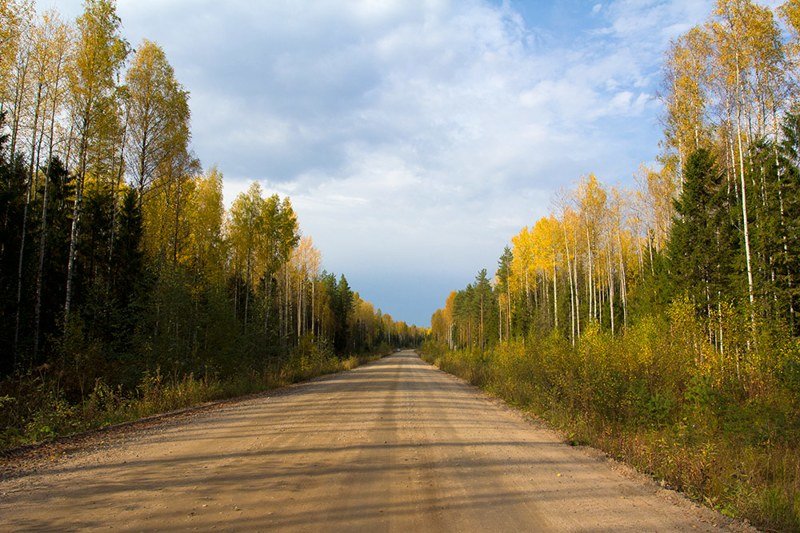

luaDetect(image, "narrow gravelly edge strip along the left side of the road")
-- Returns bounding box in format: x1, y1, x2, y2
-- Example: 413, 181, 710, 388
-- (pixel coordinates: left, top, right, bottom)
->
0, 352, 394, 482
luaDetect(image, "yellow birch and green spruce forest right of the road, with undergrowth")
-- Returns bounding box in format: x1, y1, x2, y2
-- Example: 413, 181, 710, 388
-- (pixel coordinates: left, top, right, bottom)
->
424, 0, 800, 531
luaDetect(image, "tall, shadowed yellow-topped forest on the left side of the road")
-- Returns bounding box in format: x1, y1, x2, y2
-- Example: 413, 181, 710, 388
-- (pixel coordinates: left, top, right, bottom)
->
0, 0, 424, 449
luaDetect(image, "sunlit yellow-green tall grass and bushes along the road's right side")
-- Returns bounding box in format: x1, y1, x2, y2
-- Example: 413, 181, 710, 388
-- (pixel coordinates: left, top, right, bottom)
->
423, 304, 800, 531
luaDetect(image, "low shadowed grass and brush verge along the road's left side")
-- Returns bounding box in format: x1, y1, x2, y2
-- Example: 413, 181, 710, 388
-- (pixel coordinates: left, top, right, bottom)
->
0, 341, 391, 452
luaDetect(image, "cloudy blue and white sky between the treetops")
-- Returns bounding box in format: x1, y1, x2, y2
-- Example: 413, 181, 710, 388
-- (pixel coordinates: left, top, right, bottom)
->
50, 0, 736, 326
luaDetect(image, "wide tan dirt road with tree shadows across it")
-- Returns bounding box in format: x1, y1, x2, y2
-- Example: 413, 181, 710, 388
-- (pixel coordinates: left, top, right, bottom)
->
0, 352, 744, 532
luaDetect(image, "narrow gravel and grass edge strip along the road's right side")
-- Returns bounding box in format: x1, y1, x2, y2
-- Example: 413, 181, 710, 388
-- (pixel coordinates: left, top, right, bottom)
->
415, 350, 759, 533
